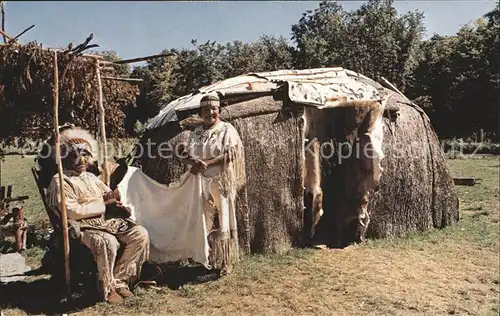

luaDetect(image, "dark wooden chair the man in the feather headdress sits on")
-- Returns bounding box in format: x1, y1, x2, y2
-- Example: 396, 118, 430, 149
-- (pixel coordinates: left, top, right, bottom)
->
31, 167, 98, 295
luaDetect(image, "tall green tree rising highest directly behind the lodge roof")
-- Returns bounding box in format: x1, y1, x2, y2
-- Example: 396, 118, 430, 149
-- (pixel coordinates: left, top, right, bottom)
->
292, 0, 425, 90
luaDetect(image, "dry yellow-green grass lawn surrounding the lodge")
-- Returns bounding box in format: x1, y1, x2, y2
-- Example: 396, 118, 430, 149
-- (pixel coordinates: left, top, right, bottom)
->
0, 156, 500, 315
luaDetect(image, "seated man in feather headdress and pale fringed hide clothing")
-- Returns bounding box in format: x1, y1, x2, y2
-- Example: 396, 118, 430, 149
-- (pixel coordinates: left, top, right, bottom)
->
47, 128, 149, 303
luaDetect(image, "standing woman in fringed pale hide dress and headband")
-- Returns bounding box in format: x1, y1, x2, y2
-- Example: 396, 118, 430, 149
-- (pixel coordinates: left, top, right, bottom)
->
185, 94, 245, 274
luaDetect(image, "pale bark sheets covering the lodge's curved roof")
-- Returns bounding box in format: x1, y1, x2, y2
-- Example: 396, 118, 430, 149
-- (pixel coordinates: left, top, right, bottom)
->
147, 67, 380, 130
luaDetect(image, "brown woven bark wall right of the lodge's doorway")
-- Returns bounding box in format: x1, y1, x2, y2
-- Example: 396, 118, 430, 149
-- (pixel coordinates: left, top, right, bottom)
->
369, 94, 459, 237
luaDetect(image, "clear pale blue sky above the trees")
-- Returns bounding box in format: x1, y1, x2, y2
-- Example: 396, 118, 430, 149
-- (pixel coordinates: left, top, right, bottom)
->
5, 0, 496, 59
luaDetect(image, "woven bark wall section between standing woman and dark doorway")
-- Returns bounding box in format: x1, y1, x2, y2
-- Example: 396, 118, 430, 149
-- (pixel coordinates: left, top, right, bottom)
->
228, 97, 303, 253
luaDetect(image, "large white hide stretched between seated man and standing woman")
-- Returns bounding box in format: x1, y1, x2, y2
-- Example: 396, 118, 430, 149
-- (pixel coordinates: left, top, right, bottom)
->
118, 167, 209, 268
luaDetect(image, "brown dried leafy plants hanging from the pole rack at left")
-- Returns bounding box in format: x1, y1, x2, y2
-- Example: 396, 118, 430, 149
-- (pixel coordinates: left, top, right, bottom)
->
0, 36, 139, 144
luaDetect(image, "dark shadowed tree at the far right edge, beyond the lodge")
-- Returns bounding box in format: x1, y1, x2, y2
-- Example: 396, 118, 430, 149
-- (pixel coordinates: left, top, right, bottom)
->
409, 12, 500, 139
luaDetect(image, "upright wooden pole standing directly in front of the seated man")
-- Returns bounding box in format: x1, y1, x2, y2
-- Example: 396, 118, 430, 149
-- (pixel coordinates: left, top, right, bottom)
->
53, 52, 71, 299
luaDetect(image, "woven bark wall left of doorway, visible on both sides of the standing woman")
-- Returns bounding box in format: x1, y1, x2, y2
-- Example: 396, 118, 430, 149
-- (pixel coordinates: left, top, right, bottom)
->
138, 97, 303, 253
